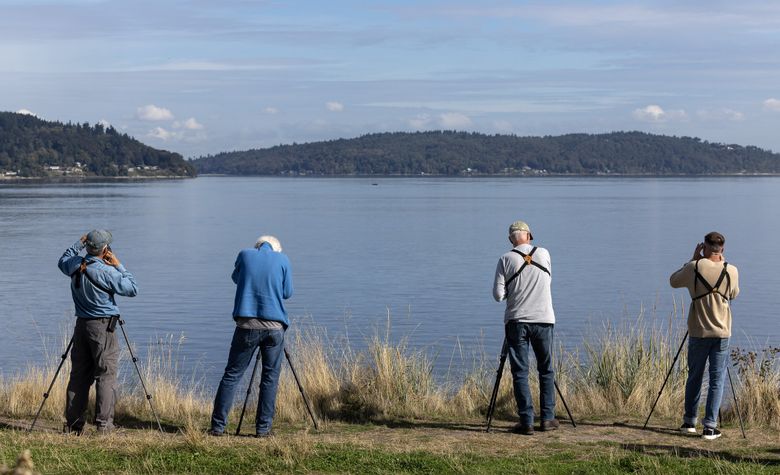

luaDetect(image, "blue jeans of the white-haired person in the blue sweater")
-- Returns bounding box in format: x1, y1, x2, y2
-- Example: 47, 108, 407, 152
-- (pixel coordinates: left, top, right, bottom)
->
211, 328, 284, 434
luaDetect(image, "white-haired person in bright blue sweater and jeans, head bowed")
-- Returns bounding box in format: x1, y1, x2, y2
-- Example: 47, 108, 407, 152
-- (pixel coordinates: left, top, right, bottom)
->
208, 236, 293, 437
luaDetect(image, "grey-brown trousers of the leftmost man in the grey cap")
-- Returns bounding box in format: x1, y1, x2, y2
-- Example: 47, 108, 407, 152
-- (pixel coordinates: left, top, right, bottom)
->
65, 318, 119, 430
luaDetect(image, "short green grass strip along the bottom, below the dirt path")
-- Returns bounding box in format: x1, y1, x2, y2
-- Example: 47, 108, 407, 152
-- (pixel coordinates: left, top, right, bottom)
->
0, 428, 780, 474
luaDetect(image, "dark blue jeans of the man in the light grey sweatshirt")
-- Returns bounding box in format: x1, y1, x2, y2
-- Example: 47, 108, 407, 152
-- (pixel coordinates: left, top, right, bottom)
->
506, 322, 555, 425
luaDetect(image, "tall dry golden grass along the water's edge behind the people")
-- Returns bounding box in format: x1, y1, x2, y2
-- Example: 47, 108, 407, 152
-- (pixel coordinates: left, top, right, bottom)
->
0, 317, 780, 432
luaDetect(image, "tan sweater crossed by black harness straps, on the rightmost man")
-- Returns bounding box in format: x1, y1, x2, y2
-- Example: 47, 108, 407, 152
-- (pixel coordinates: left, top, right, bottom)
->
669, 259, 739, 338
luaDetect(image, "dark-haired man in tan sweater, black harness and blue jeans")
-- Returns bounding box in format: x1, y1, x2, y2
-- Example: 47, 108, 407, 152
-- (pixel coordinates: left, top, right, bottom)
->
669, 231, 739, 440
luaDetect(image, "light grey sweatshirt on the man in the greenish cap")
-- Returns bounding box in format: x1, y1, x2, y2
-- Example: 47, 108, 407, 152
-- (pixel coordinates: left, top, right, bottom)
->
493, 244, 555, 323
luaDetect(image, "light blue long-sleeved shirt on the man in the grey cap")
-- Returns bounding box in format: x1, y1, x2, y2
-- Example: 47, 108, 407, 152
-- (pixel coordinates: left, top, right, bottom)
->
57, 241, 138, 318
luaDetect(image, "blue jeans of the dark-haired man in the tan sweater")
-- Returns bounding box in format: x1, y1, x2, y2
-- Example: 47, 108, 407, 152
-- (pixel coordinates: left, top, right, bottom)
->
683, 337, 729, 429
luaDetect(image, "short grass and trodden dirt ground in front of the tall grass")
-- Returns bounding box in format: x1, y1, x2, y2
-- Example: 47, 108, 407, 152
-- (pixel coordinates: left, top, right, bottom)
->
0, 419, 780, 474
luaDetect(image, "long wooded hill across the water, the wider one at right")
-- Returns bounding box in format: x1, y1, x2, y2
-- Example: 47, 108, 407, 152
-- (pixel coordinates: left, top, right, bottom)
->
192, 132, 780, 175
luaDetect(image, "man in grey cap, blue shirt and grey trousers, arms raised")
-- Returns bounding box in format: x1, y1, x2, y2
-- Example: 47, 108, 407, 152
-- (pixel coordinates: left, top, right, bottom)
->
57, 229, 138, 434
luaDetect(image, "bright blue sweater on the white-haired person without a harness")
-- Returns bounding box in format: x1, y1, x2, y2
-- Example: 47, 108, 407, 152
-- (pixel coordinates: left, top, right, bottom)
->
232, 243, 293, 328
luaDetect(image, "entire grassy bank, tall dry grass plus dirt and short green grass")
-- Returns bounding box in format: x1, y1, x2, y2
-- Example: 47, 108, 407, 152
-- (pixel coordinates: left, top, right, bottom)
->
0, 312, 780, 473
